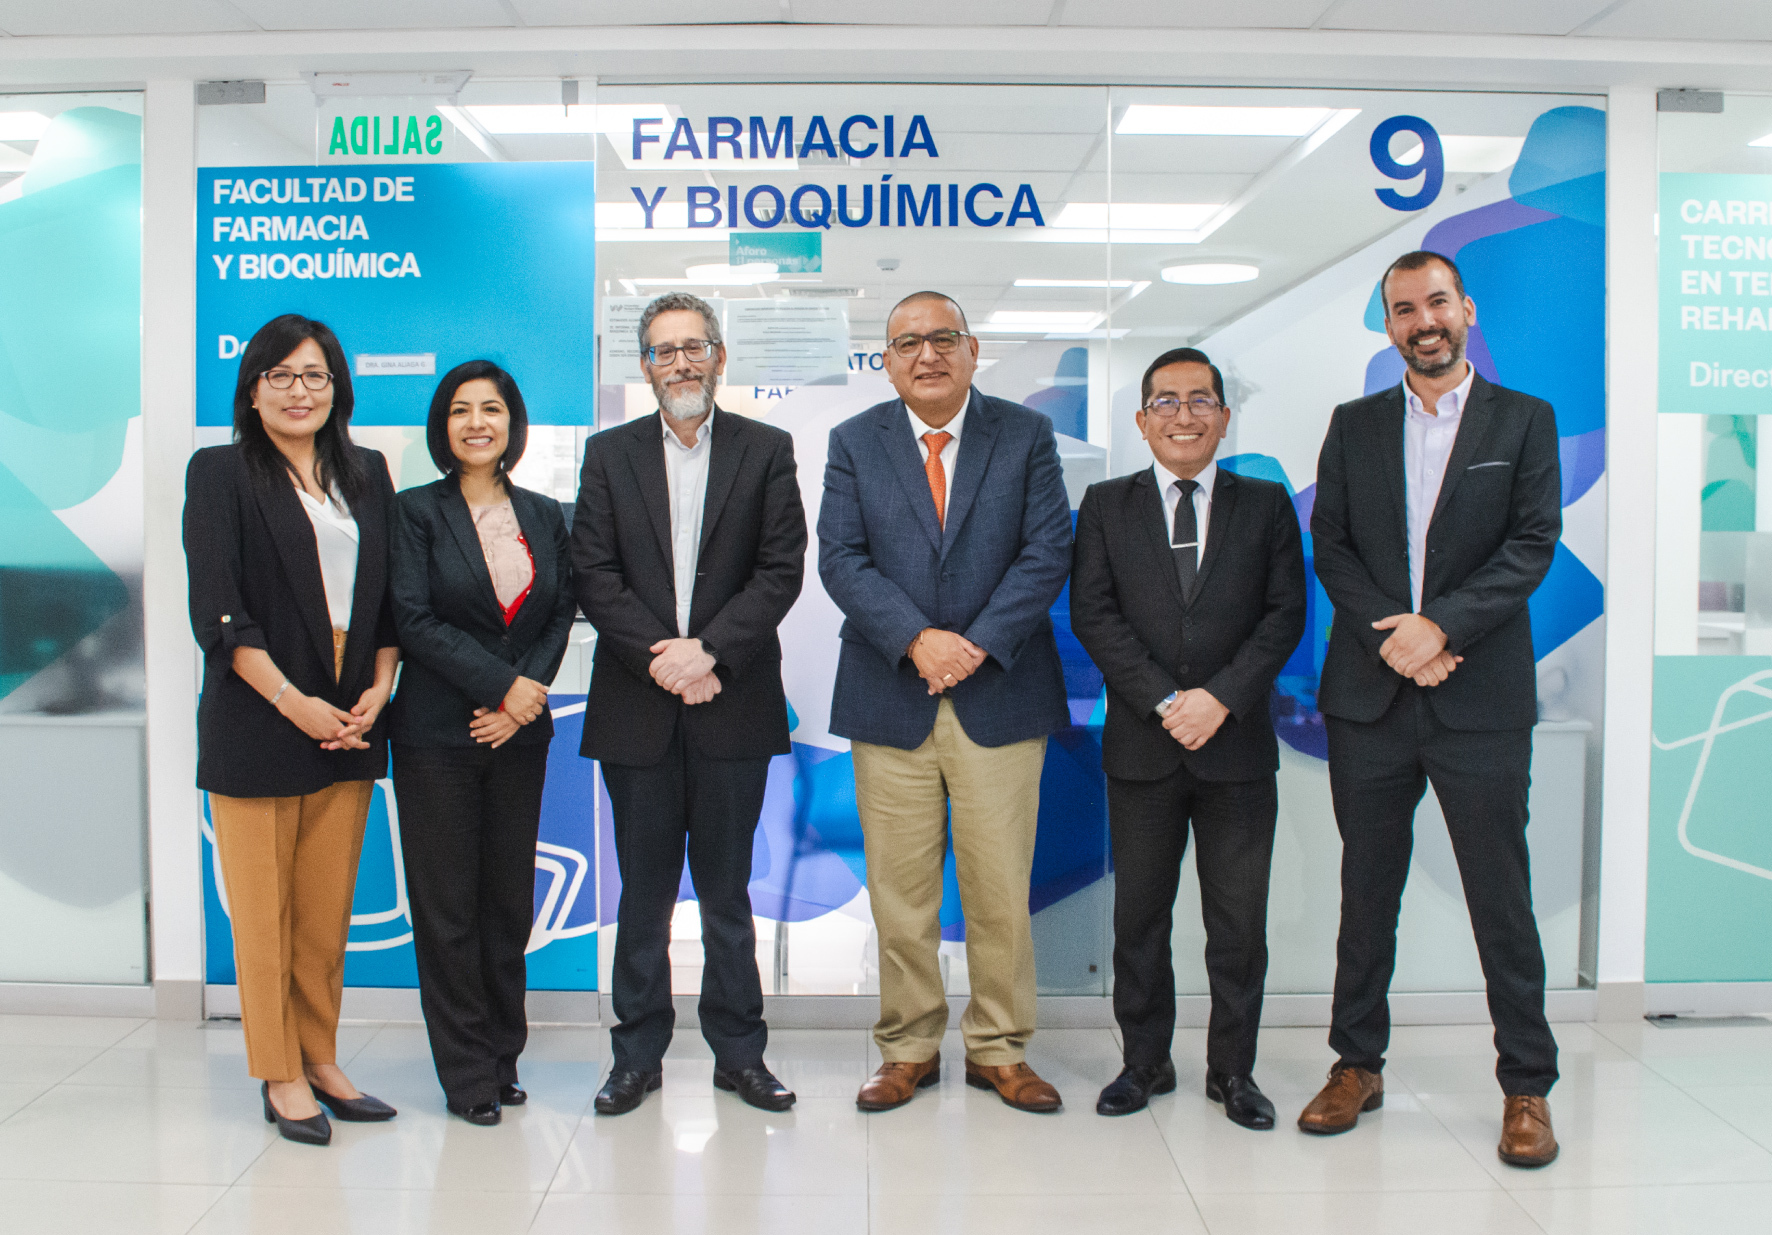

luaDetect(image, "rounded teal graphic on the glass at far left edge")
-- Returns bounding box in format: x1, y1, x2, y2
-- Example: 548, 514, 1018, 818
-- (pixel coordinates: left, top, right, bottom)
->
0, 106, 142, 698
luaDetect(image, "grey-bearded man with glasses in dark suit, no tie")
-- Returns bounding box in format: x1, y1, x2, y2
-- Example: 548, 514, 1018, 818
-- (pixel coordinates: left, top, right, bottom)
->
572, 292, 806, 1115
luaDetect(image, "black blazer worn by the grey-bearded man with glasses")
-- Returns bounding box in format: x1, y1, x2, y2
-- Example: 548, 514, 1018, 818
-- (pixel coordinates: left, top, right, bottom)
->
572, 409, 806, 767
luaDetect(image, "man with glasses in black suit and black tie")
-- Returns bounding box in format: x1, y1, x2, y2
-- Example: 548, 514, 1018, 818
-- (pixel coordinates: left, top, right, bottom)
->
1070, 347, 1306, 1130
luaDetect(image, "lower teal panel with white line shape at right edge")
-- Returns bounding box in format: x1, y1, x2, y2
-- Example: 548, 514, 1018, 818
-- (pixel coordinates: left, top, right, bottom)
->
1644, 656, 1772, 982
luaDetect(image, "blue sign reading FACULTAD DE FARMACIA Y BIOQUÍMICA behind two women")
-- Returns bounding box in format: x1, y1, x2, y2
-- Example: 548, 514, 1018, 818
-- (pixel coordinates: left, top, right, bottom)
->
197, 163, 597, 425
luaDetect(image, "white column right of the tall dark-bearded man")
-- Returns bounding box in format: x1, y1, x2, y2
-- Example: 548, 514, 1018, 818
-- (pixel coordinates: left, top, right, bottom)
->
1595, 87, 1658, 1019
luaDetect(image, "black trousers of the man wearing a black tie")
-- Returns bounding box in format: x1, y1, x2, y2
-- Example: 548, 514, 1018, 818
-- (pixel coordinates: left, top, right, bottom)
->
1108, 767, 1279, 1074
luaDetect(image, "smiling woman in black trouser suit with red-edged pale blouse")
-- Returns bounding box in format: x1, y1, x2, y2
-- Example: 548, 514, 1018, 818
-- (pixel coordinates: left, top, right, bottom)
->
390, 360, 576, 1125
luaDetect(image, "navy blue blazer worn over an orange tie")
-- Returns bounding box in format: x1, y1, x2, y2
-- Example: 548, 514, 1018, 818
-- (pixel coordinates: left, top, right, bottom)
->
819, 390, 1070, 750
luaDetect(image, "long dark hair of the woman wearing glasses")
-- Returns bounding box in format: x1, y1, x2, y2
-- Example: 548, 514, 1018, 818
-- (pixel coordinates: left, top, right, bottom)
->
234, 314, 369, 509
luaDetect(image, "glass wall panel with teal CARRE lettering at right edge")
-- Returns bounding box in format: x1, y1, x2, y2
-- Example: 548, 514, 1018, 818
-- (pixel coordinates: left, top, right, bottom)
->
1644, 94, 1772, 982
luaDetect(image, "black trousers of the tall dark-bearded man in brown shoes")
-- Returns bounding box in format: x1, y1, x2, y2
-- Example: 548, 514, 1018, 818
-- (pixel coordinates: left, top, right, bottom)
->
1325, 682, 1558, 1097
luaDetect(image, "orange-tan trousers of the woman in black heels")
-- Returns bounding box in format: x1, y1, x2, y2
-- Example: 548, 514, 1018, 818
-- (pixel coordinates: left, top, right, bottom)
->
209, 780, 376, 1081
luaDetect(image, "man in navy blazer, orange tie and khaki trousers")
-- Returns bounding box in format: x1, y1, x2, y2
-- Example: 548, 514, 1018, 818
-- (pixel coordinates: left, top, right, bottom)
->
819, 292, 1070, 1111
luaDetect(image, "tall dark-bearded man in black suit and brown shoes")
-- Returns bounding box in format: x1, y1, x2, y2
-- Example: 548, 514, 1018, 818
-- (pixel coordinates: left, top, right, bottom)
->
1299, 252, 1563, 1166
